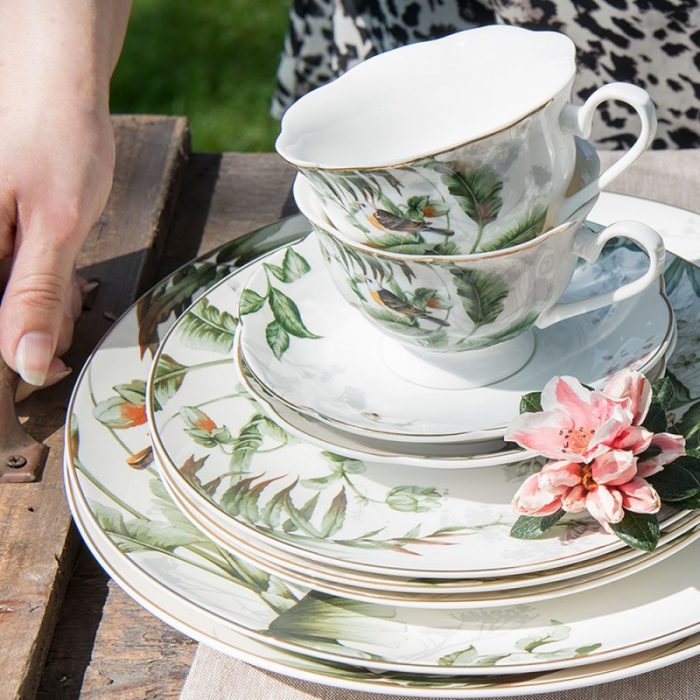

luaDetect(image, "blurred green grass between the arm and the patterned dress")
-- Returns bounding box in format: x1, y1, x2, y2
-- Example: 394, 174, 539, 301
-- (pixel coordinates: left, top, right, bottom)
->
111, 0, 291, 151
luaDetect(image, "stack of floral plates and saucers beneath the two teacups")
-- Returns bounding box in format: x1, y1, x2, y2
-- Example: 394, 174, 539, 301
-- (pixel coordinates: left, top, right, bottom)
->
65, 195, 700, 697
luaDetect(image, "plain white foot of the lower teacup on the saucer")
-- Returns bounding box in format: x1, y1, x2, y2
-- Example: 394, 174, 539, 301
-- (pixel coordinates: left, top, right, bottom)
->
382, 329, 535, 390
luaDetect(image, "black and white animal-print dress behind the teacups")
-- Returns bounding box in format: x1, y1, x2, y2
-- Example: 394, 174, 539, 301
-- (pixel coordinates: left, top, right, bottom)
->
272, 0, 700, 148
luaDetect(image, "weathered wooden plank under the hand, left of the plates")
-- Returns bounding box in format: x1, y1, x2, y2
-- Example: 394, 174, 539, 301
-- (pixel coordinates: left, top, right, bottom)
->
0, 117, 189, 698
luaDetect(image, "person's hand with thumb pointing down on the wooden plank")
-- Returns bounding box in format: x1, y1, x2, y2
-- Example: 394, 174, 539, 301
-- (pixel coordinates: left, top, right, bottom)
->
0, 105, 114, 386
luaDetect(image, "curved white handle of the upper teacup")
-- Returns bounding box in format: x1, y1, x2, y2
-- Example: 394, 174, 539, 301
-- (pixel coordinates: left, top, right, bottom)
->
559, 83, 656, 219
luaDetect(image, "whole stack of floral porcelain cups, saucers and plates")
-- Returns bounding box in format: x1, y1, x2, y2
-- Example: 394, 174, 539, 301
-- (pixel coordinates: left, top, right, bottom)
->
65, 27, 700, 697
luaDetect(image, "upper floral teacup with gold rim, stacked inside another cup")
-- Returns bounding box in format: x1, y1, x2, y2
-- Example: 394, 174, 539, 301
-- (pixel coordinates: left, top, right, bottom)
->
276, 26, 656, 255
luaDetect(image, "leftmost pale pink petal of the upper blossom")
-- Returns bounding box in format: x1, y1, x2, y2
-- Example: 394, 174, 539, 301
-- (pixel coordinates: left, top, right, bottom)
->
505, 411, 584, 462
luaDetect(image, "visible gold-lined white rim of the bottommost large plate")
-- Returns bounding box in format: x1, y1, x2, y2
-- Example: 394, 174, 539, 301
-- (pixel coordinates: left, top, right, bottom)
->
66, 476, 700, 698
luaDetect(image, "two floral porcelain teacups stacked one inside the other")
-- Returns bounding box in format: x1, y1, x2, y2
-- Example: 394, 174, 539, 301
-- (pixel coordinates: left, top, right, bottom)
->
276, 26, 664, 389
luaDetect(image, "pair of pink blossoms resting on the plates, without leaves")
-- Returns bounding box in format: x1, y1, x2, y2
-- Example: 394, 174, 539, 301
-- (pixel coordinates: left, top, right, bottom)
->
506, 370, 685, 531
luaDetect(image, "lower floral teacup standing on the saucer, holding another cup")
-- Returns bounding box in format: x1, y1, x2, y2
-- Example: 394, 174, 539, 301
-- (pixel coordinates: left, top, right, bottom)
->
294, 176, 664, 384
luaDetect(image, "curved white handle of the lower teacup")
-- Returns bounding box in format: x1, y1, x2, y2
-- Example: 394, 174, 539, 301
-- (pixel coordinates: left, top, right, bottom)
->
535, 221, 666, 328
